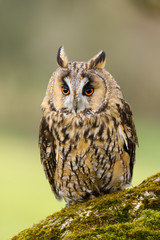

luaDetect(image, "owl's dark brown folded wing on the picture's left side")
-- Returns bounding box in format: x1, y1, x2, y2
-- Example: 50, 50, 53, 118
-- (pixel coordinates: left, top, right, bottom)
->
39, 117, 59, 199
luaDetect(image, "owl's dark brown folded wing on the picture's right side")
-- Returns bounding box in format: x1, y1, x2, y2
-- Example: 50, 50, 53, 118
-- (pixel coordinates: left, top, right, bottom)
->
120, 100, 138, 178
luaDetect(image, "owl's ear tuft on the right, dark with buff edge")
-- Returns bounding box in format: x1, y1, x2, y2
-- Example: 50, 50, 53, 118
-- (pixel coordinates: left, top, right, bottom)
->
89, 51, 106, 69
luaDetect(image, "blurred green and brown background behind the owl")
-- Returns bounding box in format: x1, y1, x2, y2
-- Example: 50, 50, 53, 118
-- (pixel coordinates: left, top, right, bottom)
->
0, 0, 160, 240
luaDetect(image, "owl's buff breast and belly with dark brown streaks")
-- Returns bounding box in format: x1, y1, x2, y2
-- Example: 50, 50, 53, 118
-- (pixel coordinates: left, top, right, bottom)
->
45, 110, 130, 202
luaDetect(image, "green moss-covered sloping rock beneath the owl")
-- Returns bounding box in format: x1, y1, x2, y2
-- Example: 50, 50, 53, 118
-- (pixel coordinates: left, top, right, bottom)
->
12, 173, 160, 240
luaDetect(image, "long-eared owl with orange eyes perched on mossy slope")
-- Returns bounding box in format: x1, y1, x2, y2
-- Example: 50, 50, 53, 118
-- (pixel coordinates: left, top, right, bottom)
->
39, 47, 138, 204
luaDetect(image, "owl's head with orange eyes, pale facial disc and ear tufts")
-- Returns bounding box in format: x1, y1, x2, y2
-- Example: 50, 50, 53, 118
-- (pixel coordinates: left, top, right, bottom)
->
42, 47, 122, 114
